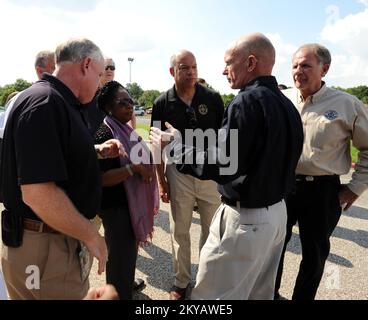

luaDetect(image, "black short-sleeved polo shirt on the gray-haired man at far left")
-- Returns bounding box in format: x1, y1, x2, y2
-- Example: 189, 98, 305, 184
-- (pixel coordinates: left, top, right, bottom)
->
1, 74, 101, 219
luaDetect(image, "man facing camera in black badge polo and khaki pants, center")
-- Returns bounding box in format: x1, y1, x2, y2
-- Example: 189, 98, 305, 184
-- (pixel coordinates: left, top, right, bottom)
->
151, 50, 224, 300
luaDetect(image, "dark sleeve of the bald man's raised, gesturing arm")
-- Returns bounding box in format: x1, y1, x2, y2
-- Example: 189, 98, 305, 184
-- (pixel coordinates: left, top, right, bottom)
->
177, 97, 263, 184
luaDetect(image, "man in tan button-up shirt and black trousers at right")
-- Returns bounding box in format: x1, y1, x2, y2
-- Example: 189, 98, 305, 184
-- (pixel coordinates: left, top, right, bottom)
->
275, 44, 368, 300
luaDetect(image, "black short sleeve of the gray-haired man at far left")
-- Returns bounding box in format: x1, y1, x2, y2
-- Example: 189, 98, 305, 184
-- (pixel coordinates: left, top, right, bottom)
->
14, 102, 68, 185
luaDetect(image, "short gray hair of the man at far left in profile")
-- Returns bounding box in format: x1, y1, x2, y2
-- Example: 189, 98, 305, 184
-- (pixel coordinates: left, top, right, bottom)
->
55, 39, 104, 64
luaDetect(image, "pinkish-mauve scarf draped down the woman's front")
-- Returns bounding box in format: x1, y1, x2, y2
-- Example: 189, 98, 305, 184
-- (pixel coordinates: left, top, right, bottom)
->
104, 116, 160, 245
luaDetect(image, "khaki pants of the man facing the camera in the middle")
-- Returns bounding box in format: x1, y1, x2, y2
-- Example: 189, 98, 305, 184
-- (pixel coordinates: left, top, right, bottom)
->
166, 165, 220, 288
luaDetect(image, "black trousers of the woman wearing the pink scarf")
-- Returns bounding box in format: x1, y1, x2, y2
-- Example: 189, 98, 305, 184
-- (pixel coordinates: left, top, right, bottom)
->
100, 208, 137, 300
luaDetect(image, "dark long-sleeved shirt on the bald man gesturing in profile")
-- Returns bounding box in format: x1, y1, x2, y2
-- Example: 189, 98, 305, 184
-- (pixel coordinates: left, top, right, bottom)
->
177, 76, 303, 208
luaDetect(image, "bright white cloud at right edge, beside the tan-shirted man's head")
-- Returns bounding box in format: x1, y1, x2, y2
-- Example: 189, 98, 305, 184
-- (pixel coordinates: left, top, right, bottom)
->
321, 6, 368, 87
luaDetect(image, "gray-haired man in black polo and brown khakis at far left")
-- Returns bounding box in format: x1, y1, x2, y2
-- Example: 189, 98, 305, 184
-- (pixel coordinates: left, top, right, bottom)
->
1, 39, 117, 299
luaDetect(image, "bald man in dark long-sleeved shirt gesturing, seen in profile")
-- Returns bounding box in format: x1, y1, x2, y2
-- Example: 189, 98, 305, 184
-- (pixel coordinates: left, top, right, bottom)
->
151, 33, 303, 300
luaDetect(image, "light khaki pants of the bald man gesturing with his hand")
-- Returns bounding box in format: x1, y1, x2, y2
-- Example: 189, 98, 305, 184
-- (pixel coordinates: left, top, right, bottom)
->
192, 201, 286, 300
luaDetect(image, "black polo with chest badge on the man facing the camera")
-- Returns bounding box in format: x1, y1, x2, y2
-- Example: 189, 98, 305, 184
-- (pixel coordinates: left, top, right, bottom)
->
151, 84, 224, 143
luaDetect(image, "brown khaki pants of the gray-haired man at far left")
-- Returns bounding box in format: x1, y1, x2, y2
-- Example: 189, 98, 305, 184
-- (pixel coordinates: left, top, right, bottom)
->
1, 230, 89, 300
